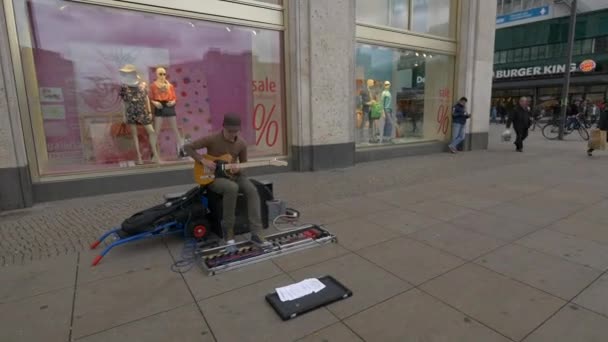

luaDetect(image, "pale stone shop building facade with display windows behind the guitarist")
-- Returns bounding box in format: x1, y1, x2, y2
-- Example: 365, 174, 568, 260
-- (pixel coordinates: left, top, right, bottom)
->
0, 0, 496, 209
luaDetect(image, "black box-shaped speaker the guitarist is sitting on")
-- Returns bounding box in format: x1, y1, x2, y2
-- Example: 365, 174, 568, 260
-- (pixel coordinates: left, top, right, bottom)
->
207, 179, 274, 238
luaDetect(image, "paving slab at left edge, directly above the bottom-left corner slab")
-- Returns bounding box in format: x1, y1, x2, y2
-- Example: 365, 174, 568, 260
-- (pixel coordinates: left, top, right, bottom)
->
0, 254, 77, 304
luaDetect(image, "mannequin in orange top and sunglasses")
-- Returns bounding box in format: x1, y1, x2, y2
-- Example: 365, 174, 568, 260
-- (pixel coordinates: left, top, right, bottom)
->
150, 67, 184, 157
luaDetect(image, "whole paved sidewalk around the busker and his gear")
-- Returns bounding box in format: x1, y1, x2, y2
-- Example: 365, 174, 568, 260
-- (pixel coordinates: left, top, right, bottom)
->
0, 126, 608, 342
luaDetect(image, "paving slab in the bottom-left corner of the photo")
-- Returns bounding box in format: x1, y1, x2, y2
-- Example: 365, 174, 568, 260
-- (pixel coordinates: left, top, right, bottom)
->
0, 287, 74, 342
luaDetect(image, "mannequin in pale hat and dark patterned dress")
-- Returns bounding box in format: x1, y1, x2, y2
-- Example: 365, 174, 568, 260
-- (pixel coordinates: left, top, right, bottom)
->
119, 64, 159, 165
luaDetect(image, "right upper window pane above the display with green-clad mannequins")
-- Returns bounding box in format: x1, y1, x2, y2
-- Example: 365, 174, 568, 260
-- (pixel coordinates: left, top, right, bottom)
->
412, 0, 456, 37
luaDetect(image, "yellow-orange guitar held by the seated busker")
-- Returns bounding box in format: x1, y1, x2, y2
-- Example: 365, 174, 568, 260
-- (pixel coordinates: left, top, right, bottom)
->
194, 154, 287, 185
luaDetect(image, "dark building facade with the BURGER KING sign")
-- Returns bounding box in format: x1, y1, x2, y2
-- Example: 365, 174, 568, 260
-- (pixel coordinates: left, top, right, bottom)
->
492, 1, 608, 114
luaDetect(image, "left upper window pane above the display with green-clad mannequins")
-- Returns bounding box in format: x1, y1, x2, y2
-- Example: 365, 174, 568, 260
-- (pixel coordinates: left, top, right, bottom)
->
356, 0, 410, 30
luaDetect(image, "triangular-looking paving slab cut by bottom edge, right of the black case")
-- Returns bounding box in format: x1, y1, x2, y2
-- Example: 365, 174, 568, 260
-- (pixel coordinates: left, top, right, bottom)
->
345, 289, 509, 342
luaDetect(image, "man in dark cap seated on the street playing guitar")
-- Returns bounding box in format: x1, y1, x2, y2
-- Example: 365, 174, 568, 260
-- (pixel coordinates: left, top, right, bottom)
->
184, 114, 271, 252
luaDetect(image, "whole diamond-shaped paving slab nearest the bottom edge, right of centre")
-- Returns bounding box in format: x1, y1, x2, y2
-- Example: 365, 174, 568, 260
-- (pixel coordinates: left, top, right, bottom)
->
421, 264, 565, 340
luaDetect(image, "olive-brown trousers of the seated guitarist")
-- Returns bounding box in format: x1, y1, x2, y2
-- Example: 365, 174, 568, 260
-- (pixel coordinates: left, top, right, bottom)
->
209, 175, 262, 240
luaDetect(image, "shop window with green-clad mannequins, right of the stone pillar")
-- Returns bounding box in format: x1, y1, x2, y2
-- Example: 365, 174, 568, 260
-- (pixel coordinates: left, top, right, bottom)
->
353, 44, 454, 147
